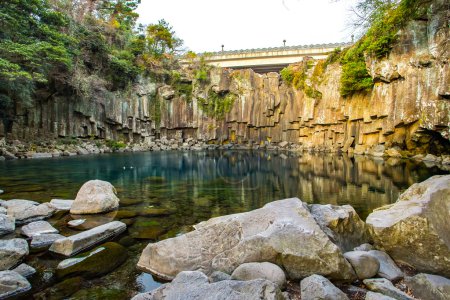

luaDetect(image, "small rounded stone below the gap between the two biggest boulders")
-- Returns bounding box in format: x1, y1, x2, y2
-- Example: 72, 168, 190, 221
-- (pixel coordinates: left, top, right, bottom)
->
344, 251, 380, 280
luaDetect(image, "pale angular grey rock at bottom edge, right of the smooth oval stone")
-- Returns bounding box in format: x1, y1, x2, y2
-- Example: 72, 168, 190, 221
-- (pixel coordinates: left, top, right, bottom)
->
300, 275, 348, 300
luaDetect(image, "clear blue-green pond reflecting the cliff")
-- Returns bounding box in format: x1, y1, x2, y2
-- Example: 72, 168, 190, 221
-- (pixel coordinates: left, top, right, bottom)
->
0, 150, 445, 299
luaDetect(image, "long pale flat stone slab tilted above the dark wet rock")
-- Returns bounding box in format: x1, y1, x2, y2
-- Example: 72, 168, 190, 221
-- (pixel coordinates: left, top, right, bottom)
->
50, 221, 127, 256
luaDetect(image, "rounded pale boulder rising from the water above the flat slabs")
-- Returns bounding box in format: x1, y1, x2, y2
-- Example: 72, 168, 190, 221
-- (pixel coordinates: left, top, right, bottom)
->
70, 180, 120, 214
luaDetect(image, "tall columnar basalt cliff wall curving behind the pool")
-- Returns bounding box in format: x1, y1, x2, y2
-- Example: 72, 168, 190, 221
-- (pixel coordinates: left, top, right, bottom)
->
0, 0, 450, 154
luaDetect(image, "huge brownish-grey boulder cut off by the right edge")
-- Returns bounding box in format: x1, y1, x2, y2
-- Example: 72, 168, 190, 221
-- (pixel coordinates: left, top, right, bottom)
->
367, 175, 450, 277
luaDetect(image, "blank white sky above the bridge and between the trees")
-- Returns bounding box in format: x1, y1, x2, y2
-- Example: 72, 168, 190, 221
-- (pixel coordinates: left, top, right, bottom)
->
137, 0, 356, 52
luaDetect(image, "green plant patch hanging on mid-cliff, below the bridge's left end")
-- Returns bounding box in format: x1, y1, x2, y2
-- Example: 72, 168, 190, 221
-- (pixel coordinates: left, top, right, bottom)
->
198, 90, 237, 120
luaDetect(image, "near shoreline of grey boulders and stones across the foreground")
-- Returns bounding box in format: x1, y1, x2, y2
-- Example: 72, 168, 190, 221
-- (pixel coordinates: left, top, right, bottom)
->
0, 175, 450, 300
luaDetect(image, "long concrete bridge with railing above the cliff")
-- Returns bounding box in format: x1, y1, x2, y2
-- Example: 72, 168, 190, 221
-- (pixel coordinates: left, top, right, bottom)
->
185, 43, 351, 73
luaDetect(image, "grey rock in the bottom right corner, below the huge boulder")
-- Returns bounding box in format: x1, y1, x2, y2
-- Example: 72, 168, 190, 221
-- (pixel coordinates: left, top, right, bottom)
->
405, 273, 450, 300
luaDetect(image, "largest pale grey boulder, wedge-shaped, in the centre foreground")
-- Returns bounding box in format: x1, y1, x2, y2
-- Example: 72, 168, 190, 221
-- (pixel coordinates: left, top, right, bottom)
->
138, 198, 355, 280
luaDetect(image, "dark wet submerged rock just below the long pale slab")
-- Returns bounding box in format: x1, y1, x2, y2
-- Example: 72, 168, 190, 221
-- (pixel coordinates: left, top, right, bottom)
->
56, 242, 128, 278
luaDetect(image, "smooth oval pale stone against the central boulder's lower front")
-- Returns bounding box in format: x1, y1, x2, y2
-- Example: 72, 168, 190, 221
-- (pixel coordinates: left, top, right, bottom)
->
231, 262, 286, 288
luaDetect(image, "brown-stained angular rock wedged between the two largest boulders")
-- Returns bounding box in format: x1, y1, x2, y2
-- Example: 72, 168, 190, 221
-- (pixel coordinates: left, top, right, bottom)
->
309, 204, 370, 251
